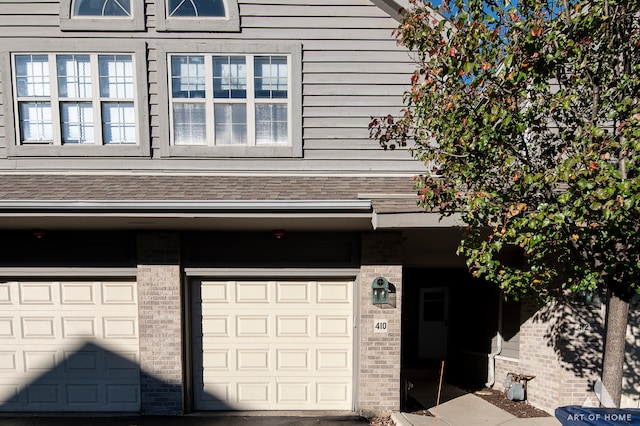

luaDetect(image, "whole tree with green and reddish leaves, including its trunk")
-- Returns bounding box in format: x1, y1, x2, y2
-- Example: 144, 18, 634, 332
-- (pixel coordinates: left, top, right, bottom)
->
369, 0, 640, 406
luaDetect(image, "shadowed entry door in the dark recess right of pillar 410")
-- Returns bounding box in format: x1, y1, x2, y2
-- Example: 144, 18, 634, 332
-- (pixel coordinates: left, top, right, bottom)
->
418, 287, 449, 360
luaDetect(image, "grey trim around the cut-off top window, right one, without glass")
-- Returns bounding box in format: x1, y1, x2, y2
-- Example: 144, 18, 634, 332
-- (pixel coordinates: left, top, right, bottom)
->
155, 0, 240, 32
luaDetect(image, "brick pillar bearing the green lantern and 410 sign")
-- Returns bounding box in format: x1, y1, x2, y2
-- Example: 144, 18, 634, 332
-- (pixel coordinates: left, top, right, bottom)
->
358, 232, 402, 417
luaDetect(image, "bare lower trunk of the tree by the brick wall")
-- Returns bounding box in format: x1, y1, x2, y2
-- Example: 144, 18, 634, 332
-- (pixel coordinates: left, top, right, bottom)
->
602, 292, 629, 408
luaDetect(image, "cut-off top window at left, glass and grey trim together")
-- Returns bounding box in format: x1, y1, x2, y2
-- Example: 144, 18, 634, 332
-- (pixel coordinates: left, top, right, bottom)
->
60, 0, 144, 31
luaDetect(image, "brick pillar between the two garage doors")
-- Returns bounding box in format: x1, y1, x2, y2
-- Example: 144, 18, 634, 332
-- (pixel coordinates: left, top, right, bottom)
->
137, 232, 183, 415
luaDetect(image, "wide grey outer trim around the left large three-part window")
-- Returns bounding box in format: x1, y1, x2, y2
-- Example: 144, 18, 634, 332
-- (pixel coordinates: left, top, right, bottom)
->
0, 39, 151, 157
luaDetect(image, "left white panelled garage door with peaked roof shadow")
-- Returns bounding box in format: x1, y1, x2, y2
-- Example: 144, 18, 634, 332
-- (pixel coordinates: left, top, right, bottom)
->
0, 281, 140, 411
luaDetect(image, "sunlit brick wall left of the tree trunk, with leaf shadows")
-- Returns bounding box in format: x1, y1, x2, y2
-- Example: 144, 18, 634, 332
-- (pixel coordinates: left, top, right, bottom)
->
516, 300, 604, 413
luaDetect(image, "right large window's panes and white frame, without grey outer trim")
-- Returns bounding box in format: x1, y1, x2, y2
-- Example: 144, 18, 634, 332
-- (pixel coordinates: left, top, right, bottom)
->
170, 55, 291, 146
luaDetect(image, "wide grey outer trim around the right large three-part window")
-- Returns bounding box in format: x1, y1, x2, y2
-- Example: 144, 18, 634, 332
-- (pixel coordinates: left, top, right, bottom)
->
157, 41, 302, 158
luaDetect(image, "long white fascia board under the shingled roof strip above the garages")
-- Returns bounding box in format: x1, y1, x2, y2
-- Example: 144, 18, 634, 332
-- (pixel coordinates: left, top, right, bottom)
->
0, 200, 372, 214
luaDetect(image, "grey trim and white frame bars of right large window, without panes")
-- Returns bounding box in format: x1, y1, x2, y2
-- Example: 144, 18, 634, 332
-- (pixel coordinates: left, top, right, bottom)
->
157, 42, 302, 157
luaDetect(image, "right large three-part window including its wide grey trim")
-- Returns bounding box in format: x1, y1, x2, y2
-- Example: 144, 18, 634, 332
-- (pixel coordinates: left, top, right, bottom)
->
156, 40, 302, 158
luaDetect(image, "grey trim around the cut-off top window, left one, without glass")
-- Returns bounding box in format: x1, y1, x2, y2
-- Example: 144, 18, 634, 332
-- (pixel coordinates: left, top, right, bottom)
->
60, 0, 145, 31
